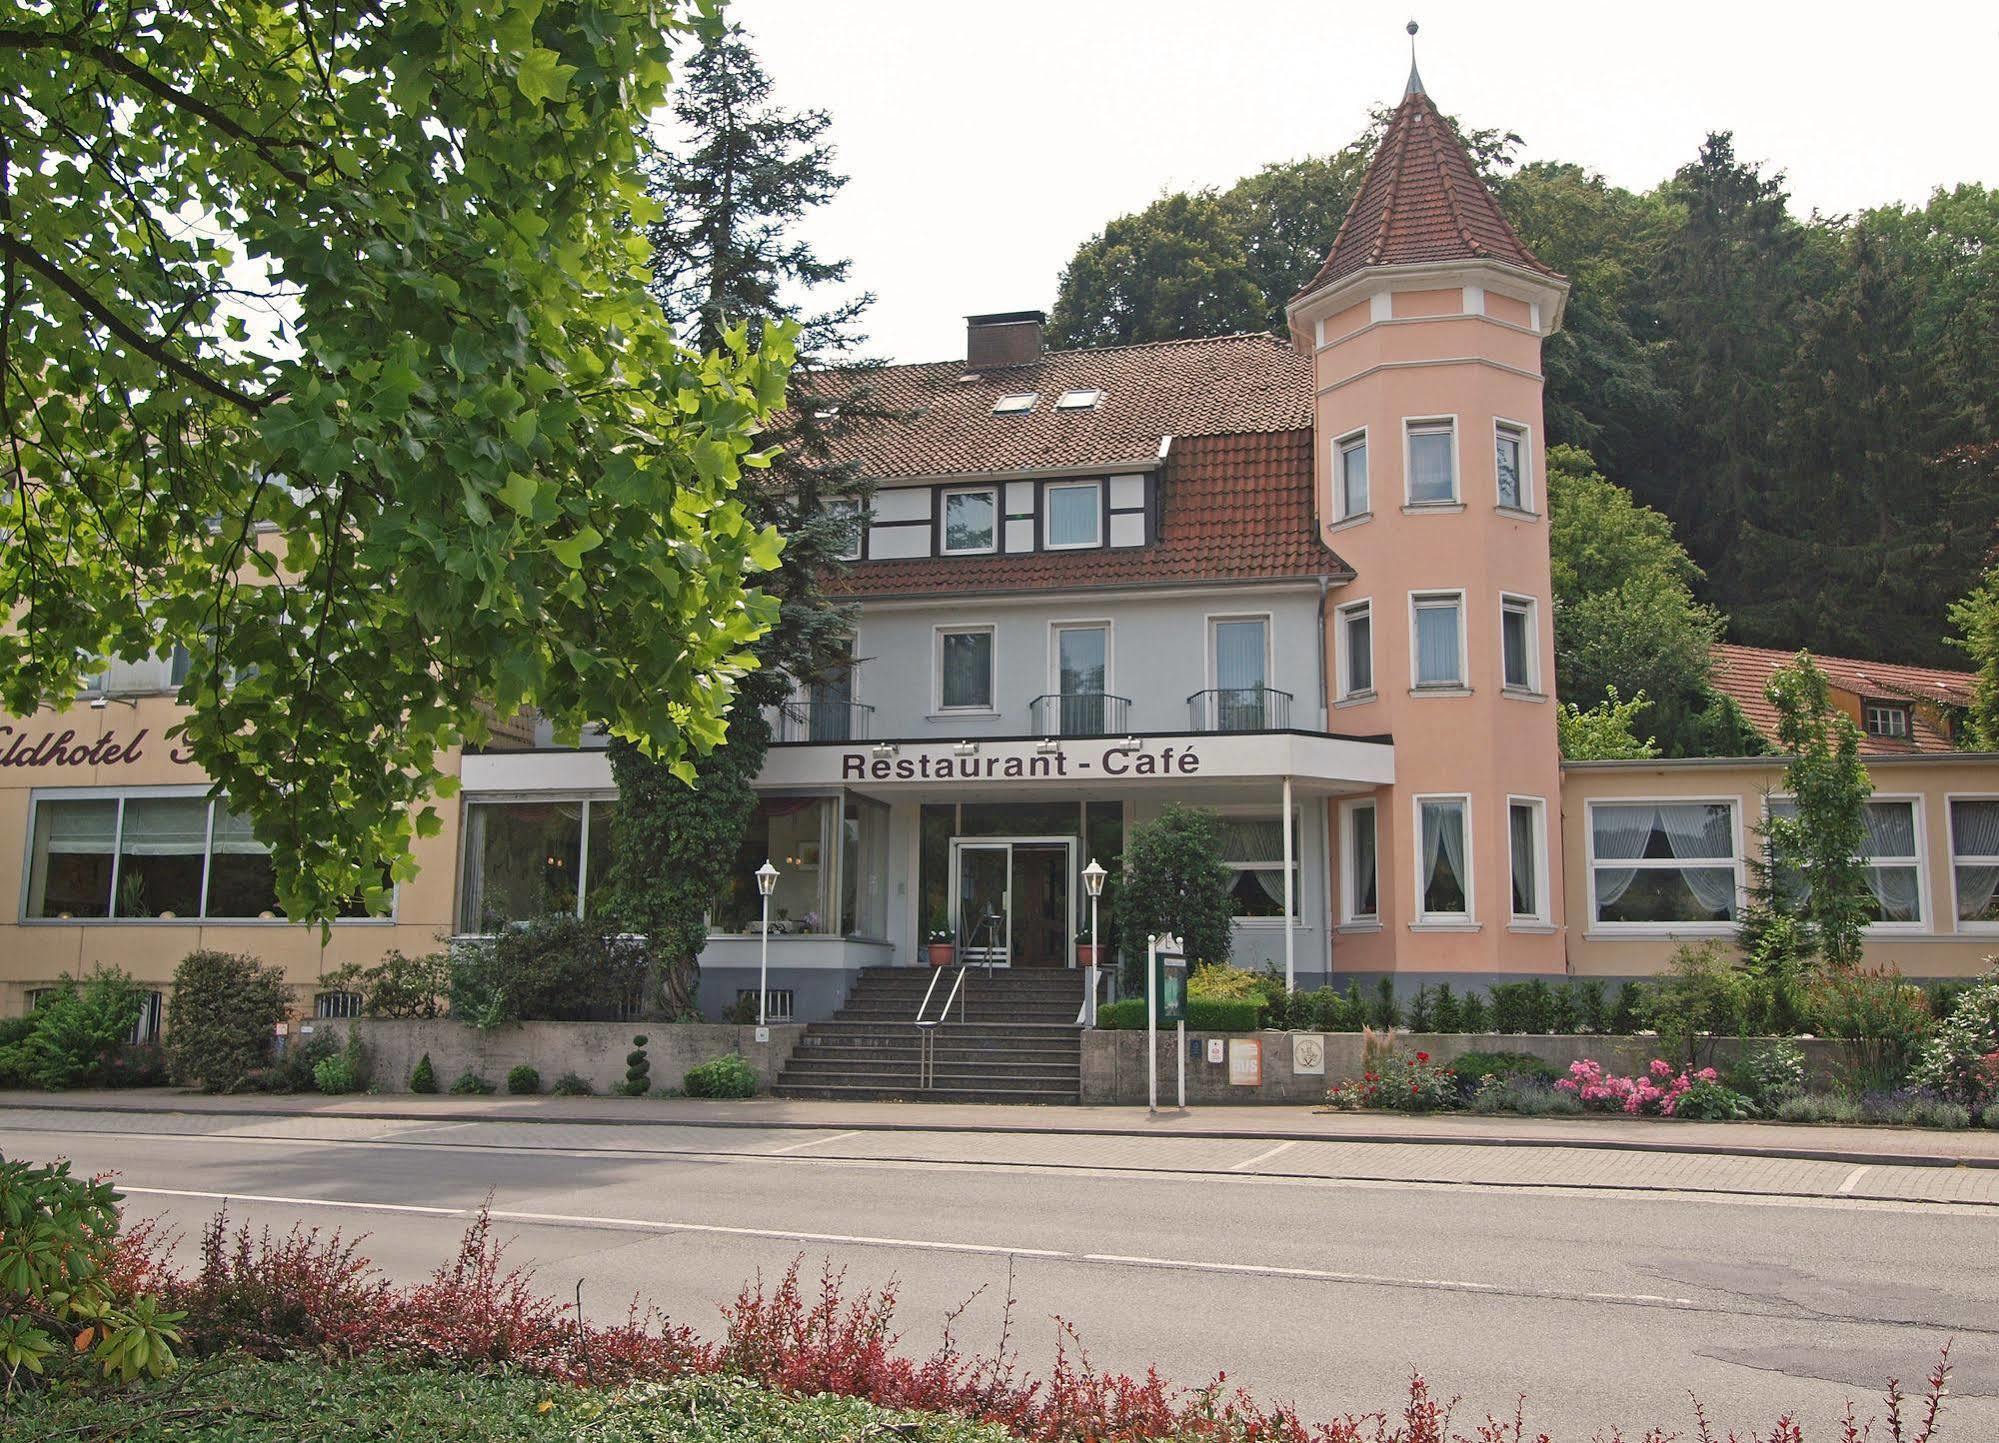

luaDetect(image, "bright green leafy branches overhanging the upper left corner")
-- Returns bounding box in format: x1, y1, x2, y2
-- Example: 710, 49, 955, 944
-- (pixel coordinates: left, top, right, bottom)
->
0, 0, 790, 919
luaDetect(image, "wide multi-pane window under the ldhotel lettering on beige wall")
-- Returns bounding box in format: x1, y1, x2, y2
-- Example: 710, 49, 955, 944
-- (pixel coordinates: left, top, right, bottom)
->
22, 793, 345, 921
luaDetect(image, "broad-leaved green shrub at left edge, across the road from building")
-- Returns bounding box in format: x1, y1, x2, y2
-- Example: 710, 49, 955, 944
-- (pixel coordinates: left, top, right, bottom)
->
0, 1159, 182, 1383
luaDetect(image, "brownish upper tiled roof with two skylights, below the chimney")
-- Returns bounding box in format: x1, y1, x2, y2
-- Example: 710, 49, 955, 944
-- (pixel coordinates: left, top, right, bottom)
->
795, 334, 1311, 480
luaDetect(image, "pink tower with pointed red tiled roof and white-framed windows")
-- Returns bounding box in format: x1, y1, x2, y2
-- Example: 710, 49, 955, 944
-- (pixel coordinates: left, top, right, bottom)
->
1289, 72, 1567, 975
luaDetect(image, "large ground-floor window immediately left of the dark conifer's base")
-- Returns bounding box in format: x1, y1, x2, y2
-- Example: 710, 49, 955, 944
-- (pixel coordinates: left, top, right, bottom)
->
458, 797, 618, 931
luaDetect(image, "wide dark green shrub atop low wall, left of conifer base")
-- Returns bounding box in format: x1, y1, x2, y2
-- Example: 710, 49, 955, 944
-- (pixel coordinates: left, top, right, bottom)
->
450, 911, 646, 1031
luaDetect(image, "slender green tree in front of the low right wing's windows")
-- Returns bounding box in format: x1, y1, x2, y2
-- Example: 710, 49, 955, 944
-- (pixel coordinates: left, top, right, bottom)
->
1763, 652, 1875, 967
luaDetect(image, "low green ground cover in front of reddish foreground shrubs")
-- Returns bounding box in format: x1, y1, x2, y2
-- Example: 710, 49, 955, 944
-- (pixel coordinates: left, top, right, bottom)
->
8, 1355, 1013, 1443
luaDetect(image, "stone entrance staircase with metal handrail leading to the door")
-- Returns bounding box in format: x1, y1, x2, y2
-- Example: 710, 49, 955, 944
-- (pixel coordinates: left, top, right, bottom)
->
772, 965, 1083, 1103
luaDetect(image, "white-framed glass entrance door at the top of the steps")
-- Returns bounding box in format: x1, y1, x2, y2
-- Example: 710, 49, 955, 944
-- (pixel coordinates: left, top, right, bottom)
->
952, 837, 1075, 967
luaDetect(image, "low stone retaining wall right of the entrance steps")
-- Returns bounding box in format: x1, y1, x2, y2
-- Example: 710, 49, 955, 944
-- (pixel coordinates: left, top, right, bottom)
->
1083, 1029, 1839, 1107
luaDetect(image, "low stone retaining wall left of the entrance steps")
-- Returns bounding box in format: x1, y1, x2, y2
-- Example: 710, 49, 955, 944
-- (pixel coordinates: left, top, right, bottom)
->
314, 1017, 806, 1093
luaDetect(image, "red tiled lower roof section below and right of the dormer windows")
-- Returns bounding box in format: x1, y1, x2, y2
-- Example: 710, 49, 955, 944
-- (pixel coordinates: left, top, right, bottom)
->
828, 428, 1353, 598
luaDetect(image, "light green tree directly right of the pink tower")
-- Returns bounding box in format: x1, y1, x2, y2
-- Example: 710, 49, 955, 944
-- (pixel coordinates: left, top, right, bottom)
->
1547, 446, 1763, 757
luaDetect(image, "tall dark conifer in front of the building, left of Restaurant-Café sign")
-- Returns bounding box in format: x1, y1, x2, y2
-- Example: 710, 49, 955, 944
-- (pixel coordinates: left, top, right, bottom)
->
612, 28, 888, 1015
